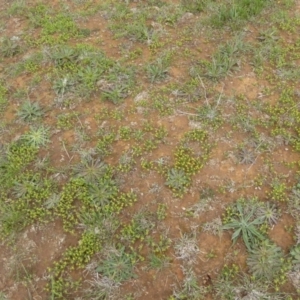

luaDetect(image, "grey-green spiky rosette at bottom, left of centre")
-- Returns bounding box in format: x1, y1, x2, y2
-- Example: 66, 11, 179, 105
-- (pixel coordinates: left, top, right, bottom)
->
96, 247, 136, 283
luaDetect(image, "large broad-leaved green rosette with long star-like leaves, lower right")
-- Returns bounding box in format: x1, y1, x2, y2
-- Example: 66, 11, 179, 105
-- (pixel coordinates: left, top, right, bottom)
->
223, 201, 264, 250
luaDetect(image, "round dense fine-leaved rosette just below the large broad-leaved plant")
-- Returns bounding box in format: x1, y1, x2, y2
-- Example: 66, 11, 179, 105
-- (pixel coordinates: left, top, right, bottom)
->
247, 240, 283, 280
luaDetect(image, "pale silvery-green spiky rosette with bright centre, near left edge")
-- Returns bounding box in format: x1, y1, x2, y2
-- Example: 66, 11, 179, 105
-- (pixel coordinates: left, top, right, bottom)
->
21, 125, 50, 148
